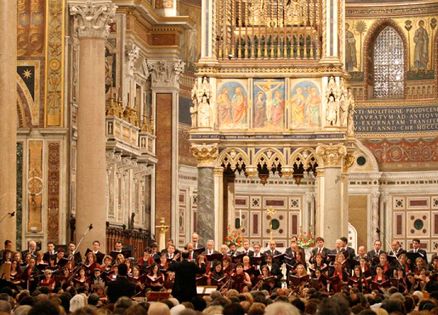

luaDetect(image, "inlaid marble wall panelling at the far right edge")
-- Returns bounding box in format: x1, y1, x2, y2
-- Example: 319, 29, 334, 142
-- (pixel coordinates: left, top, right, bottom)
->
392, 195, 438, 252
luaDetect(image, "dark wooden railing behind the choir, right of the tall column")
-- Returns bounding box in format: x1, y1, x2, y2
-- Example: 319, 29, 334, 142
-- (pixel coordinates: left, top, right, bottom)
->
106, 222, 154, 258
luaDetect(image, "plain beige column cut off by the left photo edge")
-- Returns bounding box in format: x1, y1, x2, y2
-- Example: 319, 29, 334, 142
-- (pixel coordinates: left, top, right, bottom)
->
0, 0, 17, 248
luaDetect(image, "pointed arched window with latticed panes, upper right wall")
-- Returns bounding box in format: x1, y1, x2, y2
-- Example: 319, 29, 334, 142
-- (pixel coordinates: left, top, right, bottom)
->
373, 26, 405, 98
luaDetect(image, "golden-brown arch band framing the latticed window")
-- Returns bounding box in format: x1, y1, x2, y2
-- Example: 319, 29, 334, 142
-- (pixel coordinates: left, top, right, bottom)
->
363, 19, 409, 99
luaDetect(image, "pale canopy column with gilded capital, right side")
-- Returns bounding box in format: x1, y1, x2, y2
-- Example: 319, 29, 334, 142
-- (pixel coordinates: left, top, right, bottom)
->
316, 144, 348, 248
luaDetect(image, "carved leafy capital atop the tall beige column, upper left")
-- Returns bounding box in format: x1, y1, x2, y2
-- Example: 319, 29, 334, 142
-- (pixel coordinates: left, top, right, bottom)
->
69, 0, 117, 39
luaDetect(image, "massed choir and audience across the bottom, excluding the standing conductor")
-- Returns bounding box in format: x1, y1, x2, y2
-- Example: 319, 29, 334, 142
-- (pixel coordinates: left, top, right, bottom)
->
0, 233, 438, 315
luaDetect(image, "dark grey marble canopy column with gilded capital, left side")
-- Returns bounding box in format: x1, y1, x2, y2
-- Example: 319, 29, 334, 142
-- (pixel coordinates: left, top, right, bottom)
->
192, 144, 219, 243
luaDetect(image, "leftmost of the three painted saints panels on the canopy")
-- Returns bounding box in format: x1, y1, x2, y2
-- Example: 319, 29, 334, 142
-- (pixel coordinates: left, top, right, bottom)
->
216, 80, 248, 129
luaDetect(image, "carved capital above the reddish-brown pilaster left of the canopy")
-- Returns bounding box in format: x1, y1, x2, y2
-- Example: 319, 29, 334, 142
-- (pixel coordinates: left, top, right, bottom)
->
146, 59, 185, 89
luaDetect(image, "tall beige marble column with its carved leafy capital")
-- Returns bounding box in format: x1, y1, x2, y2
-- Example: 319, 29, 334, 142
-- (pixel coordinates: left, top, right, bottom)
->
70, 0, 115, 252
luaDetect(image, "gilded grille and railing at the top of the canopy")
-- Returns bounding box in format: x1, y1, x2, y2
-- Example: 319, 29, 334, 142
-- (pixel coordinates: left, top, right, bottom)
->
215, 0, 322, 60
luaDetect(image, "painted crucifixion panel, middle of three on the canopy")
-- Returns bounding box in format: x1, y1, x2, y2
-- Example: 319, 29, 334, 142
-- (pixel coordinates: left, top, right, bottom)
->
253, 79, 285, 129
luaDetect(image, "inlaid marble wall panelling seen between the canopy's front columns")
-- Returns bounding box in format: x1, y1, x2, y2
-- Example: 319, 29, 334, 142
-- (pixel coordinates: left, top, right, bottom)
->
234, 194, 303, 247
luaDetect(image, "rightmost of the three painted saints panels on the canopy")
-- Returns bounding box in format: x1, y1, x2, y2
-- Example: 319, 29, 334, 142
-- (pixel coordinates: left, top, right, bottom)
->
289, 80, 321, 129
